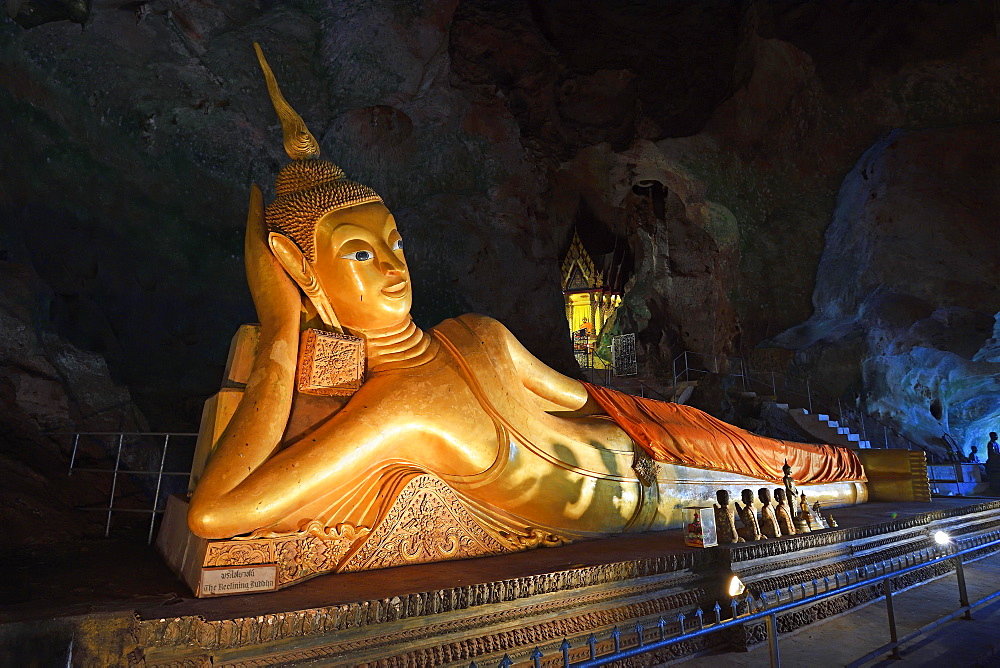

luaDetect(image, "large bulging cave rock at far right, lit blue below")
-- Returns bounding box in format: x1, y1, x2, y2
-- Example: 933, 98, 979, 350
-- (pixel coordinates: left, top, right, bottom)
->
774, 123, 1000, 454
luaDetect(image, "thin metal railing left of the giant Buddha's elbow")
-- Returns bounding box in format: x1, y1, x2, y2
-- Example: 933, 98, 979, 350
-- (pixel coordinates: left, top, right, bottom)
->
65, 432, 198, 544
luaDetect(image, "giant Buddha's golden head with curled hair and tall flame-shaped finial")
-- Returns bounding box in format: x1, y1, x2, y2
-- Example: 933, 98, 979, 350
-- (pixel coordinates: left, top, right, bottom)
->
254, 44, 413, 332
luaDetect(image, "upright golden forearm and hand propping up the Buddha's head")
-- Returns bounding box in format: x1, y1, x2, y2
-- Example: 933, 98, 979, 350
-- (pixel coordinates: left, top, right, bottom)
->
188, 185, 301, 535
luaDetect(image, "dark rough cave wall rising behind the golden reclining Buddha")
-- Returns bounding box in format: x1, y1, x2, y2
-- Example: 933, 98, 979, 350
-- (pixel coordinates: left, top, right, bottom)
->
0, 0, 1000, 544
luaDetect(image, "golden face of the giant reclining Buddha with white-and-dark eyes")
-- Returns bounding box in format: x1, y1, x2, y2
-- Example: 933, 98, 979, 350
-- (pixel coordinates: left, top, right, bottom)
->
313, 202, 413, 331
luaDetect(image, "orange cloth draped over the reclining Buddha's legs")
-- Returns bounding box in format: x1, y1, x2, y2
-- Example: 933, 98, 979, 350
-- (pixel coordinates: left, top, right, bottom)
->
584, 383, 866, 484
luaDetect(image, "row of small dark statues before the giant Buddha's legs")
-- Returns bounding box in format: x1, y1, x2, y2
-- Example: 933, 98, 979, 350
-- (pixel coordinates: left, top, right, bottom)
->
715, 487, 837, 544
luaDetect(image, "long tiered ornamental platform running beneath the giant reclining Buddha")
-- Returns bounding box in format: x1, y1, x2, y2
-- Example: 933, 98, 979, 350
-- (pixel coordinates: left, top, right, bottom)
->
139, 500, 1000, 668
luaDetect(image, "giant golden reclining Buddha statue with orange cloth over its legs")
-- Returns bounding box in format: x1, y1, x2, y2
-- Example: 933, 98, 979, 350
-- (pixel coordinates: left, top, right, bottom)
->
176, 48, 866, 584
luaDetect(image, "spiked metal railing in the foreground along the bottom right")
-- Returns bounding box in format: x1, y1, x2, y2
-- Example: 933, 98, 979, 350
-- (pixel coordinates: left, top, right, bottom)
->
470, 531, 1000, 668
